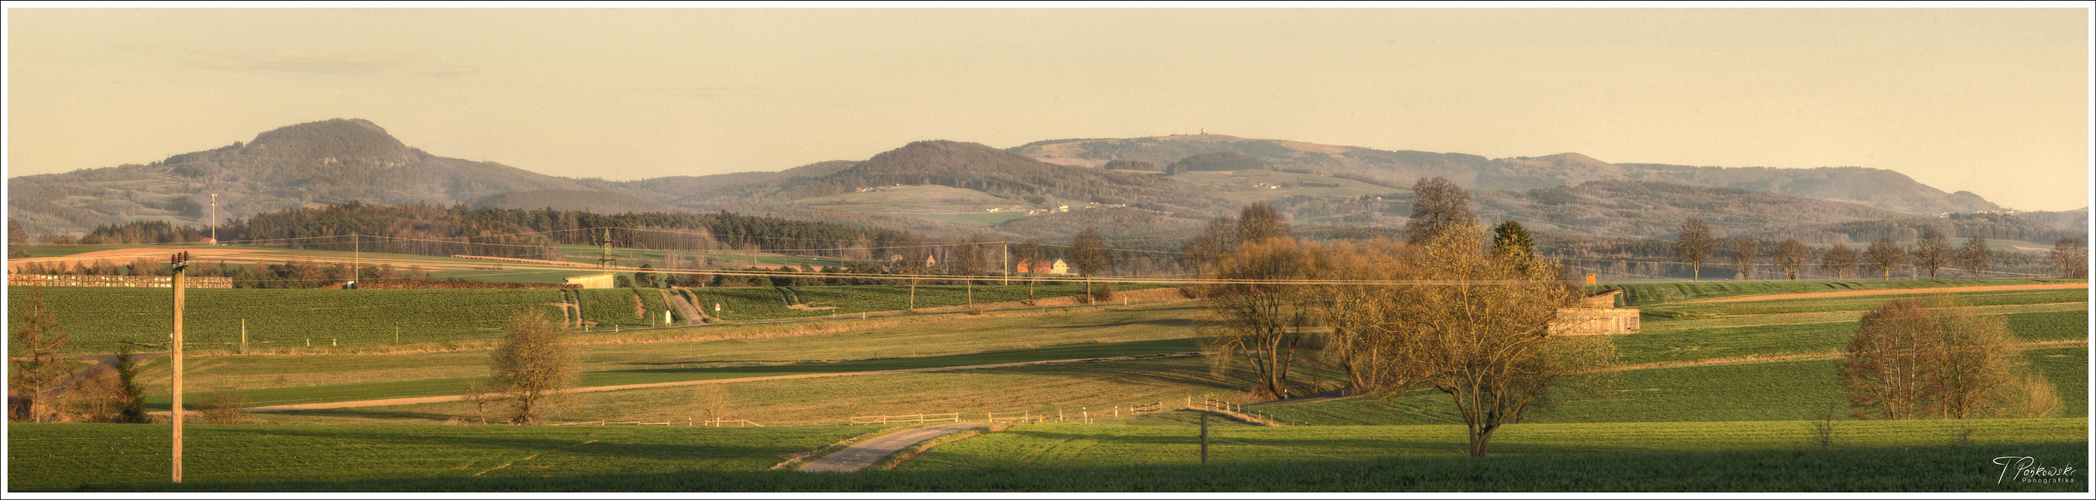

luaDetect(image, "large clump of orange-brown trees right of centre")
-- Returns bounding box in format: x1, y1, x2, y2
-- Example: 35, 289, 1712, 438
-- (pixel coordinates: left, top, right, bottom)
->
1186, 178, 1614, 456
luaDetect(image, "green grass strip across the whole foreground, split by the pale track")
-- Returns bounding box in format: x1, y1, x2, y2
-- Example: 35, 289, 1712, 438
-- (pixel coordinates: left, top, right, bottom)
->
8, 418, 2088, 492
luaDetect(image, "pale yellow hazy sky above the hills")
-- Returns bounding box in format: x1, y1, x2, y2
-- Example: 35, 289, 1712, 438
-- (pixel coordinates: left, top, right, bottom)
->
6, 8, 2090, 209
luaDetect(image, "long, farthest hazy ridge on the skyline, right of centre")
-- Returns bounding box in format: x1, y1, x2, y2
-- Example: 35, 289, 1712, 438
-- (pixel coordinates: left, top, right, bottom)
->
1010, 134, 2002, 215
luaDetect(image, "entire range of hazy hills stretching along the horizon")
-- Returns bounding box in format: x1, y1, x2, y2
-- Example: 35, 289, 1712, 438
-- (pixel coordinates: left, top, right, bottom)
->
8, 119, 2086, 238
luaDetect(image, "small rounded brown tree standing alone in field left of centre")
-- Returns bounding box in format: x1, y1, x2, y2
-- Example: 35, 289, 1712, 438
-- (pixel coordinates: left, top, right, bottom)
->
488, 310, 581, 425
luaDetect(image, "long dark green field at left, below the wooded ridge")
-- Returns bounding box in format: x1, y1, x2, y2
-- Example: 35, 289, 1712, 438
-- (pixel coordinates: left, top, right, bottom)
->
8, 285, 1165, 351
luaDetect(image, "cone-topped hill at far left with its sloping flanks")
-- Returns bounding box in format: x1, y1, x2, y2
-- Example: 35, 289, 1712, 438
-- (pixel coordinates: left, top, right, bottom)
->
6, 119, 585, 232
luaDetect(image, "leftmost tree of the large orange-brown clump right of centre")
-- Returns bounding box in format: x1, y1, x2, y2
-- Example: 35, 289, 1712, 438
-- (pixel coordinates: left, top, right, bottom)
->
1205, 238, 1312, 400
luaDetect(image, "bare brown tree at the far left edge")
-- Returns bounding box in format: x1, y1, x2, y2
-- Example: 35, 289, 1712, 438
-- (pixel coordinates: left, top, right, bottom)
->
6, 287, 71, 423
